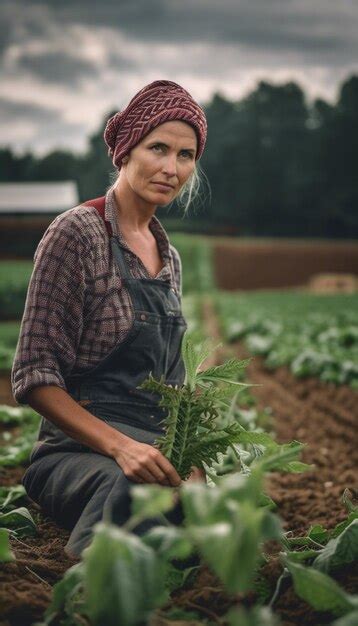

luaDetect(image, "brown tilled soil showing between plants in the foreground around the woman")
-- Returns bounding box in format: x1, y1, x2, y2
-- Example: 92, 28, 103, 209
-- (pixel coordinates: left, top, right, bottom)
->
0, 306, 358, 626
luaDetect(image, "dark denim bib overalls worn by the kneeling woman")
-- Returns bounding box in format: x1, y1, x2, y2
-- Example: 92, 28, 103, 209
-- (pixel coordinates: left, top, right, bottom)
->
22, 199, 187, 556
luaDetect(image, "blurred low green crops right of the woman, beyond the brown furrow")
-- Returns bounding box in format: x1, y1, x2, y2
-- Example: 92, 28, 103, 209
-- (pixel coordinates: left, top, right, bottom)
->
213, 292, 358, 389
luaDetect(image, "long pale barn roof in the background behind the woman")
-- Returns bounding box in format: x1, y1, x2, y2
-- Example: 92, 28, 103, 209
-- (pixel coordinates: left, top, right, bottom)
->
0, 180, 79, 213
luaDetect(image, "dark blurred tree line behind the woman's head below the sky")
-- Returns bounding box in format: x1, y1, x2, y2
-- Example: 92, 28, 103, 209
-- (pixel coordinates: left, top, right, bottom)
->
0, 76, 358, 238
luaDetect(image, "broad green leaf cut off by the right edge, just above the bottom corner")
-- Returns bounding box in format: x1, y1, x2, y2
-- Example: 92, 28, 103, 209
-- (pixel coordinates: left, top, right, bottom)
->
312, 520, 358, 573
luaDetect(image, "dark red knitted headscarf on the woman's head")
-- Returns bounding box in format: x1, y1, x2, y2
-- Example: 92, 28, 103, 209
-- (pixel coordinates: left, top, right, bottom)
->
104, 80, 207, 170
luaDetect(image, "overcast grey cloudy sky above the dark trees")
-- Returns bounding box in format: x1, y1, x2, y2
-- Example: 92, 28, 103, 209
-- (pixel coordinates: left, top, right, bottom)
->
0, 0, 358, 154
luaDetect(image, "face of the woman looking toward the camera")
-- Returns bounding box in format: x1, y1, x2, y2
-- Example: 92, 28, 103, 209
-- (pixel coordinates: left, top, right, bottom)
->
122, 120, 197, 205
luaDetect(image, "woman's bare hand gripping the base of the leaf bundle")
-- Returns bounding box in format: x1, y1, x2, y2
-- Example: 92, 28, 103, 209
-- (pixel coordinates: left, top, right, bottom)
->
113, 439, 181, 487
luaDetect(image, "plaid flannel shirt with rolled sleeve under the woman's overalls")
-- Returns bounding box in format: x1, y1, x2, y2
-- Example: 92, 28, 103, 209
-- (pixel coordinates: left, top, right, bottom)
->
11, 186, 181, 404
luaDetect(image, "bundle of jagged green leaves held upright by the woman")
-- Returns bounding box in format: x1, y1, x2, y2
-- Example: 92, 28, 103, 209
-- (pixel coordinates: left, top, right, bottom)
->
140, 335, 253, 480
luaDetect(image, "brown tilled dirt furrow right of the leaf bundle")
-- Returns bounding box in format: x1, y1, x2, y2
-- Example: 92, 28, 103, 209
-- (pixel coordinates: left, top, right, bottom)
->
235, 344, 358, 534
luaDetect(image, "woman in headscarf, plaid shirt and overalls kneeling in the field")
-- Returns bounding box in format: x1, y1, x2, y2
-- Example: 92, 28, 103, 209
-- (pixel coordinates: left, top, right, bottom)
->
11, 80, 207, 557
